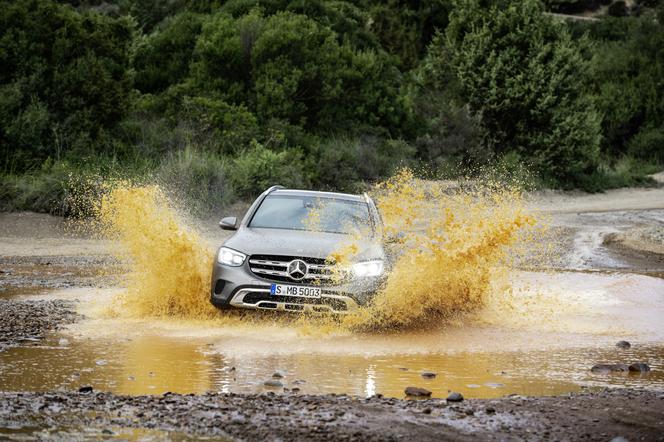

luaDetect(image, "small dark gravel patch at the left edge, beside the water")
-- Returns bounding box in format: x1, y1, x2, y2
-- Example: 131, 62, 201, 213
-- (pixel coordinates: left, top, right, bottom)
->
0, 300, 79, 352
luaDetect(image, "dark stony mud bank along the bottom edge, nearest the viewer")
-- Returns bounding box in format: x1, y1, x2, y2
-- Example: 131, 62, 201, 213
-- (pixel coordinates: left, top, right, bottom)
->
0, 390, 664, 441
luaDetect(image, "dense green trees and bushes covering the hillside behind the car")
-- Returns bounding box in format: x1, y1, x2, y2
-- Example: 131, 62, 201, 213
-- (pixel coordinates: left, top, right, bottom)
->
0, 0, 664, 214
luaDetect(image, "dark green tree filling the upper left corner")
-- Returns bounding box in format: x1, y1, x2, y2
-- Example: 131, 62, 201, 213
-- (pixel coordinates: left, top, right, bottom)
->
0, 0, 132, 170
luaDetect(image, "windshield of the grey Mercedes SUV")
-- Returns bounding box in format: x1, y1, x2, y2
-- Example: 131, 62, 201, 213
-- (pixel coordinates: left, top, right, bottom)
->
249, 195, 371, 234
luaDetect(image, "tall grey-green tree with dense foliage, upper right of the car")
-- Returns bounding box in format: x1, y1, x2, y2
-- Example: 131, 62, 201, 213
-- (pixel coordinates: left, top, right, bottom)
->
440, 0, 600, 185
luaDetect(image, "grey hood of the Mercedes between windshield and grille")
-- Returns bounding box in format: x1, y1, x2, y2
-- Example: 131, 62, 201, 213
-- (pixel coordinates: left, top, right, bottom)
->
224, 227, 385, 261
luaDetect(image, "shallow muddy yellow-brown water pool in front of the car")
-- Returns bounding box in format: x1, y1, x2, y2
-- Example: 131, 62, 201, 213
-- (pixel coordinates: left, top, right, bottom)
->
0, 272, 664, 397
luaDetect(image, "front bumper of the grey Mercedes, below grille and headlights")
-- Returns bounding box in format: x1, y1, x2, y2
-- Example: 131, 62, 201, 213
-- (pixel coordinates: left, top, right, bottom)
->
210, 262, 384, 314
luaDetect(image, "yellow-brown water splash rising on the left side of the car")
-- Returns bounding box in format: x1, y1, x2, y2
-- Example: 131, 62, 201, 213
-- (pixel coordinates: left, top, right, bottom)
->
97, 183, 215, 318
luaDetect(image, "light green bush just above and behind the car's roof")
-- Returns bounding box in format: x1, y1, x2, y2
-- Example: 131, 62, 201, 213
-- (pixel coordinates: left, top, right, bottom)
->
228, 143, 310, 197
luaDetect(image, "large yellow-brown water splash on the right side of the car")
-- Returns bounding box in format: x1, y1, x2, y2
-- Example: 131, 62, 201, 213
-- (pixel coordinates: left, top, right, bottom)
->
344, 170, 535, 329
